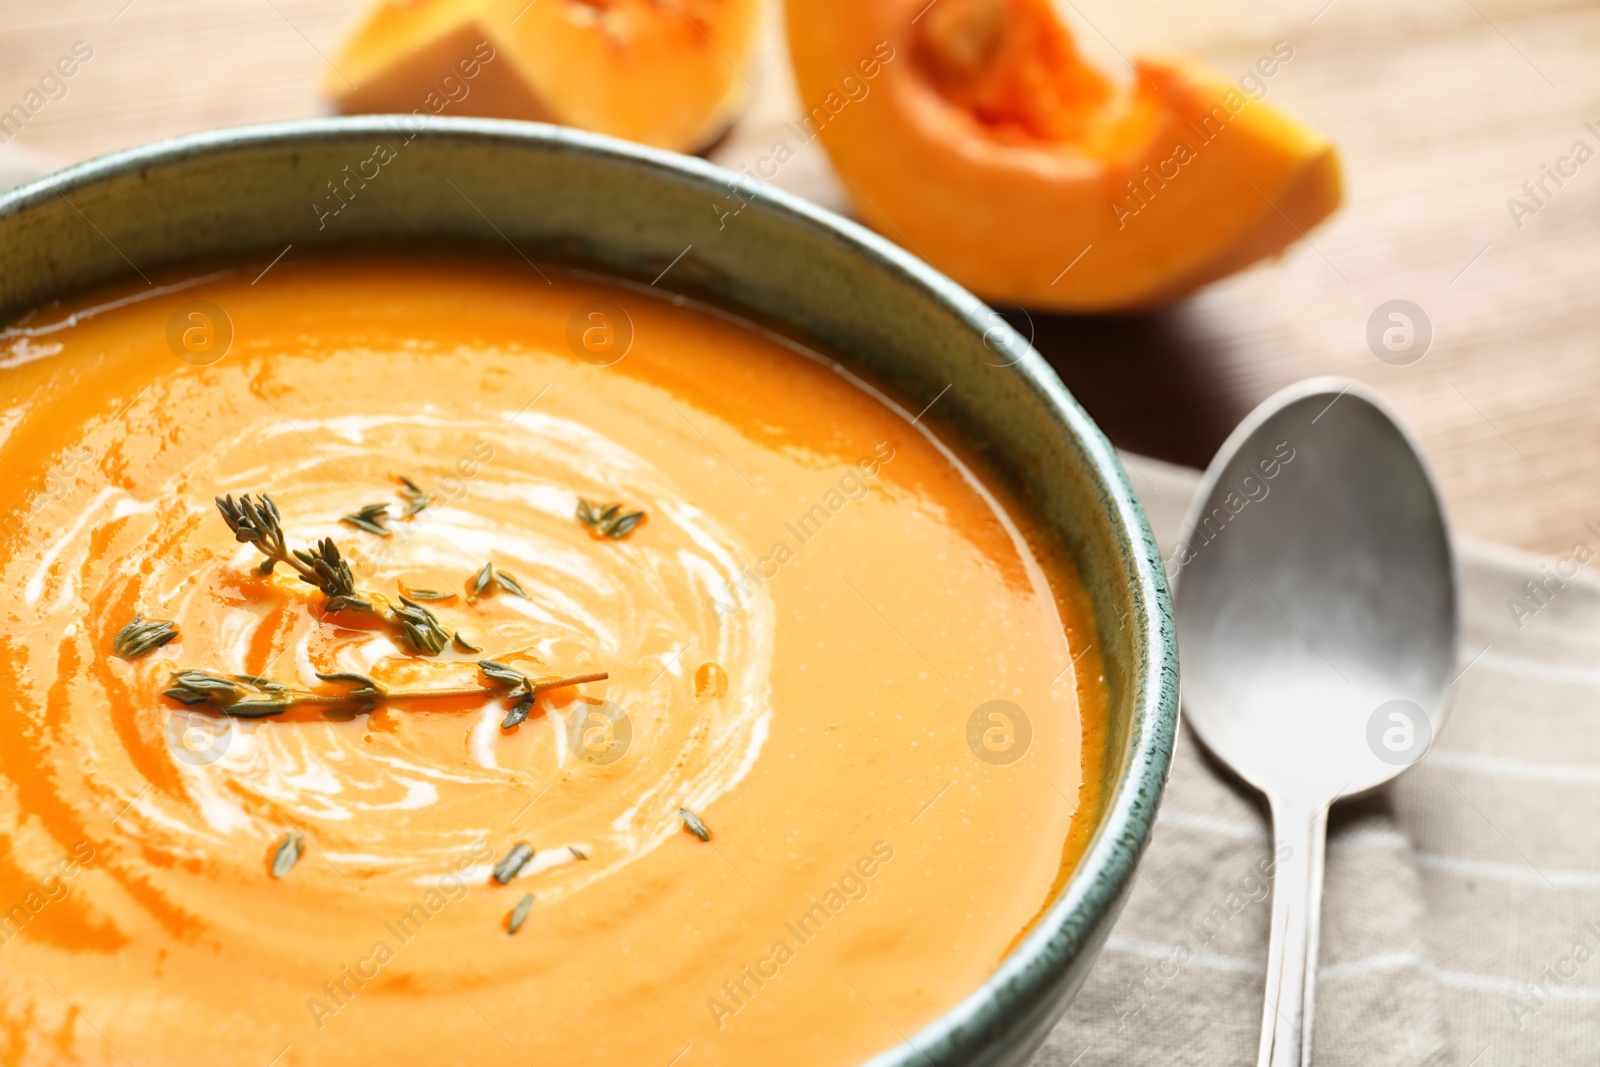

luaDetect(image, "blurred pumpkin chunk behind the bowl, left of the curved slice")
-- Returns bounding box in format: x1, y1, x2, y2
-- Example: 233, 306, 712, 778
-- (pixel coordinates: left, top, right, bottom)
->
325, 0, 760, 150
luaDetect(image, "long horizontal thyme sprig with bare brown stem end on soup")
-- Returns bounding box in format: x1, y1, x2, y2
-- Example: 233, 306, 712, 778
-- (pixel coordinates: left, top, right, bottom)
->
165, 661, 610, 721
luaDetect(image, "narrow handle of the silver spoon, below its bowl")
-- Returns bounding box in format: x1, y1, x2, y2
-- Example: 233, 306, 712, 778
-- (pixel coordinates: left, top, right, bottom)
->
1256, 797, 1328, 1067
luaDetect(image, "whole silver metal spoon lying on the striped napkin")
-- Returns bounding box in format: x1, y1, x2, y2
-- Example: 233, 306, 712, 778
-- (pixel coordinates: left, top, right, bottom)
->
1173, 379, 1458, 1067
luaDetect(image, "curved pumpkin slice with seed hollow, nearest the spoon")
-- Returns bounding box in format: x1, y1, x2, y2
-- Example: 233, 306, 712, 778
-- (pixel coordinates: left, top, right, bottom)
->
787, 0, 1341, 310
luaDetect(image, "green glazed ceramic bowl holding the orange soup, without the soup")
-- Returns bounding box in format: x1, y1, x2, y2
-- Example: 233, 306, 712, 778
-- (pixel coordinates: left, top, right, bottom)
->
0, 117, 1178, 1067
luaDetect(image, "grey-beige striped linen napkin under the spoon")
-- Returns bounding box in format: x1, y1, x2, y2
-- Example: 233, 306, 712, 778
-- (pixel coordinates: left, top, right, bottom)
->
1034, 456, 1600, 1067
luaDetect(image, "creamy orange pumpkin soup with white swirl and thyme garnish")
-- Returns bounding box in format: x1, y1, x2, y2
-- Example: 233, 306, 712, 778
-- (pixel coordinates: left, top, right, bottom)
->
0, 251, 1104, 1067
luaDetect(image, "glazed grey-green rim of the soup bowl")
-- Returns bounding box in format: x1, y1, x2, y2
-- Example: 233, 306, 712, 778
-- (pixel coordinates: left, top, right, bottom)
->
0, 115, 1179, 1067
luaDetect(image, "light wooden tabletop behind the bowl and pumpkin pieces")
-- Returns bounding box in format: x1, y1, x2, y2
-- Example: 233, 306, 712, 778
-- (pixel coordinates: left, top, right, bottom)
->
0, 0, 1600, 552
